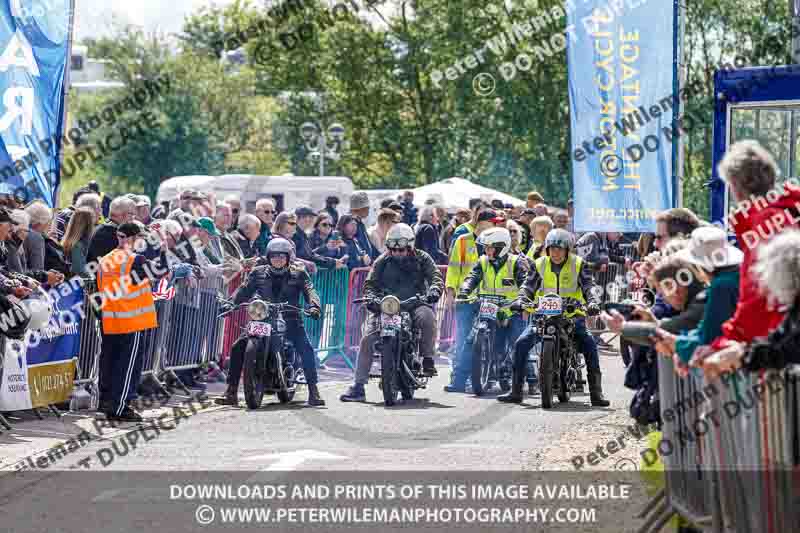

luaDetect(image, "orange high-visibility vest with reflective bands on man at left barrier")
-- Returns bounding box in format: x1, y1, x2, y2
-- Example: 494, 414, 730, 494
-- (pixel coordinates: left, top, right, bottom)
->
97, 249, 158, 335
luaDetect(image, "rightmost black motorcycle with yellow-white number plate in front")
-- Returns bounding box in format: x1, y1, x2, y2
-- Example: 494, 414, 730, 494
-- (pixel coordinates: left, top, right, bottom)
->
526, 294, 586, 409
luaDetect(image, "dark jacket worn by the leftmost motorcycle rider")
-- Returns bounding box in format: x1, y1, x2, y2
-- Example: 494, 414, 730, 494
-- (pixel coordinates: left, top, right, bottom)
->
233, 264, 321, 320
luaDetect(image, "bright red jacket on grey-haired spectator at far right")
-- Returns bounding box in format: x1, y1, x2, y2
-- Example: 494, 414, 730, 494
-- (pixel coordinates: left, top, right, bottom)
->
711, 185, 800, 350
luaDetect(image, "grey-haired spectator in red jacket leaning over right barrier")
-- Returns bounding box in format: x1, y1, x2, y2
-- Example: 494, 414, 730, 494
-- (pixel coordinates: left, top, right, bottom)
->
695, 140, 800, 375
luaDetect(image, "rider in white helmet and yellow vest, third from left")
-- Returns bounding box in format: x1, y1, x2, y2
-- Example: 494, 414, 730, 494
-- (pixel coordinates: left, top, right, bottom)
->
444, 228, 527, 392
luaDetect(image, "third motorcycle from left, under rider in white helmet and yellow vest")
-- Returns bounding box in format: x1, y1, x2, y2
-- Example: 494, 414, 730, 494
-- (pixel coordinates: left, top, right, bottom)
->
456, 294, 513, 396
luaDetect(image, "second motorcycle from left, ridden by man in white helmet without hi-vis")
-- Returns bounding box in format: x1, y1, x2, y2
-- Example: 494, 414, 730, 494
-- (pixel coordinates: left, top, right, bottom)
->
353, 295, 428, 407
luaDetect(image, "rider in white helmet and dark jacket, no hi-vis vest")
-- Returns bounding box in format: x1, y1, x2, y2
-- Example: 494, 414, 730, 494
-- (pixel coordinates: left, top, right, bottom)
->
340, 224, 444, 402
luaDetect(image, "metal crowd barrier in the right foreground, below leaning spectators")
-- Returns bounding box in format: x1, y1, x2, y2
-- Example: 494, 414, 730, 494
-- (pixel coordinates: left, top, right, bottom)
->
639, 357, 800, 533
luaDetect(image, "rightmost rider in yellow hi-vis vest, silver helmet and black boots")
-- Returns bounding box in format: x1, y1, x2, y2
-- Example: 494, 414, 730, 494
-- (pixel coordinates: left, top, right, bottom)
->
497, 229, 610, 407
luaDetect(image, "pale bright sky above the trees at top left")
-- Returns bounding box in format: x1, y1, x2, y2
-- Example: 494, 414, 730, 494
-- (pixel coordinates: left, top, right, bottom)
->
75, 0, 233, 41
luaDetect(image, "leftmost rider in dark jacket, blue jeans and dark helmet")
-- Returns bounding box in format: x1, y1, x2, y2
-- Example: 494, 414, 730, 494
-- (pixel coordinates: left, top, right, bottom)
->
217, 237, 325, 406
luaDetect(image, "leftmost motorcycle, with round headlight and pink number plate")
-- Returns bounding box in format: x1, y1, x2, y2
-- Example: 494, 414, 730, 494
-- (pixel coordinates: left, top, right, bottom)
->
217, 298, 308, 409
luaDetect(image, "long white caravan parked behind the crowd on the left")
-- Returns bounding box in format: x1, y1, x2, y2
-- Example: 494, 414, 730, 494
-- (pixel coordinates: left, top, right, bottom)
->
156, 174, 353, 213
